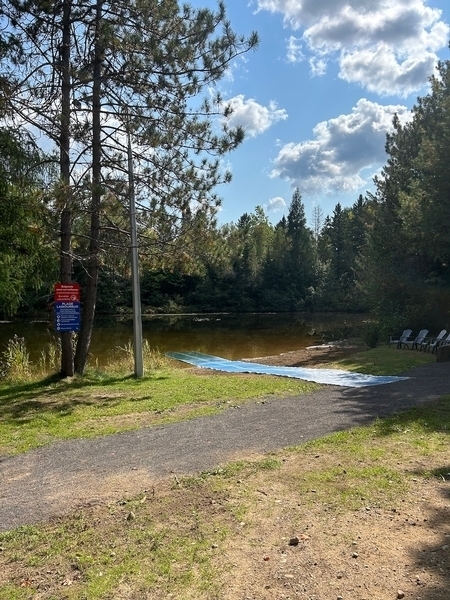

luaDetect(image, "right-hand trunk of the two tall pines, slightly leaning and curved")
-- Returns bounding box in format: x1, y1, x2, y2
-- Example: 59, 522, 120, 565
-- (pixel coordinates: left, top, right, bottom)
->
75, 0, 104, 375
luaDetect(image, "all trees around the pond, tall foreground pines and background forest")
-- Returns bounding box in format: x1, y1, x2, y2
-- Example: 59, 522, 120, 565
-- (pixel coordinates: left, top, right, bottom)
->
0, 0, 450, 375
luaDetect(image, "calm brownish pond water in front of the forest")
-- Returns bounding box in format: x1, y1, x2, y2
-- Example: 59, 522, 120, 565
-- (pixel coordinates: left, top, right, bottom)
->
0, 314, 363, 364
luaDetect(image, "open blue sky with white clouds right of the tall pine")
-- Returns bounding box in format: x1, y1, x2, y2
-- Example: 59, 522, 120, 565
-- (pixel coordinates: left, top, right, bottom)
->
189, 0, 450, 226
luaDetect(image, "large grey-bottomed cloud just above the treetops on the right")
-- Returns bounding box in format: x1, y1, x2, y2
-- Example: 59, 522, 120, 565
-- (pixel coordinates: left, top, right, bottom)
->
271, 98, 411, 195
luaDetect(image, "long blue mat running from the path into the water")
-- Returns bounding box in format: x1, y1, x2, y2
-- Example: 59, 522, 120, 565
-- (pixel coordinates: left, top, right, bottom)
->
167, 352, 408, 387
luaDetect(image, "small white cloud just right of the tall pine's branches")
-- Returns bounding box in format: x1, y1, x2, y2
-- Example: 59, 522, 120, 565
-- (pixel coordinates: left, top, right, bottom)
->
224, 94, 288, 137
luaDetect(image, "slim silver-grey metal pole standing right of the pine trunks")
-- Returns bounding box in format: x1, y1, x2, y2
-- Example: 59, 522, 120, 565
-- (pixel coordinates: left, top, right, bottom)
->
127, 130, 144, 377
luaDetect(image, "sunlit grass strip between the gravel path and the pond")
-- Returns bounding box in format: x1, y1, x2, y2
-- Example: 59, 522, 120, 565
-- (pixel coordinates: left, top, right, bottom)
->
0, 368, 318, 454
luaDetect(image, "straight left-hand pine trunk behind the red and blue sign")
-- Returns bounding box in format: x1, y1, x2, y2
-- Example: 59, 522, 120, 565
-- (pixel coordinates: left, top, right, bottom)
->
59, 0, 74, 377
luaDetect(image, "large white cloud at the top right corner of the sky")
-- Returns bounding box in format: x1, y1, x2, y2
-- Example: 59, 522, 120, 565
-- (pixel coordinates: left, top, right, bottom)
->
258, 0, 450, 96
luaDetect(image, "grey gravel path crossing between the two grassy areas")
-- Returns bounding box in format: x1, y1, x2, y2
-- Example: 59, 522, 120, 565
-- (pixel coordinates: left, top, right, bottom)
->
0, 363, 450, 531
